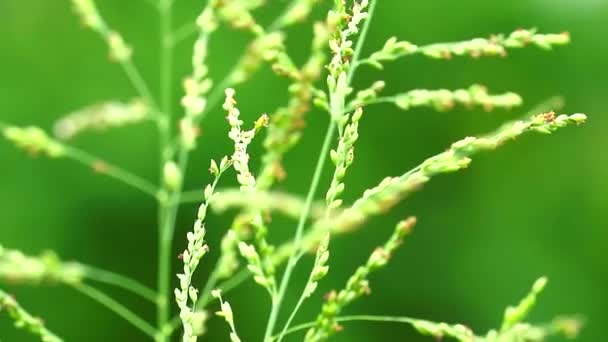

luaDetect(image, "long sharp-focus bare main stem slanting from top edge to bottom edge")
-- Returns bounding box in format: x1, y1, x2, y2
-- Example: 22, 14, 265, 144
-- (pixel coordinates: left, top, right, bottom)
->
264, 1, 377, 342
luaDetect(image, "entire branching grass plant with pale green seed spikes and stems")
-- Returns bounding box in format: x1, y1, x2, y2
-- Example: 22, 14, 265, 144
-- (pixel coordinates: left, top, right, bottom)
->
0, 0, 586, 342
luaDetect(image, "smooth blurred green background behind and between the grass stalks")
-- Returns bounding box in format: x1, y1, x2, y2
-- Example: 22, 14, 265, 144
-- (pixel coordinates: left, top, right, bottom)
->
0, 0, 608, 342
